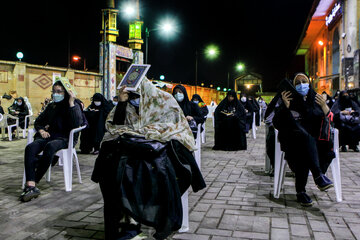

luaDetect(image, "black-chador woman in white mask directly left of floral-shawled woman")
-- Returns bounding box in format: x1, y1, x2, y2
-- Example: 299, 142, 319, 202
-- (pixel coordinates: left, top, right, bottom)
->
80, 93, 113, 155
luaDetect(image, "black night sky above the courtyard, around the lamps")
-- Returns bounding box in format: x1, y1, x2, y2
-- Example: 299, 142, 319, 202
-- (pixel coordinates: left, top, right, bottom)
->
0, 0, 313, 91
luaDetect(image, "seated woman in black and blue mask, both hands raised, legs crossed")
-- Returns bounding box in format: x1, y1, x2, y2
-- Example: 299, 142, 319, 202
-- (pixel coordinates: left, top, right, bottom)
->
273, 73, 335, 206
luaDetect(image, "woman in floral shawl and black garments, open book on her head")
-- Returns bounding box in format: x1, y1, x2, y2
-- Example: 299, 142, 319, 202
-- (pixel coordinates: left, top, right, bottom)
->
92, 79, 205, 240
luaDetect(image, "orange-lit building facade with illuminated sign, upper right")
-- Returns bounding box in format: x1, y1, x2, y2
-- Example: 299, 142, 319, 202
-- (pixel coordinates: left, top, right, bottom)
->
296, 0, 360, 94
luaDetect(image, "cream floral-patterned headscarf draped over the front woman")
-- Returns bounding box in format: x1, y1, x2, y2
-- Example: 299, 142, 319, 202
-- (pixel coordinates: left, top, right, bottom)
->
103, 79, 196, 151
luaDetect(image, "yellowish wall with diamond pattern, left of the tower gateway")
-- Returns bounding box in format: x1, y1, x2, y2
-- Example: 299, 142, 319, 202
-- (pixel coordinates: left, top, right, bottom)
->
0, 61, 101, 116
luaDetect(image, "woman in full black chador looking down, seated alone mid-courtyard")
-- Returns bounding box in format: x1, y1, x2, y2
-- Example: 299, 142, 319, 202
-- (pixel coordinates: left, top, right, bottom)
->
213, 91, 246, 151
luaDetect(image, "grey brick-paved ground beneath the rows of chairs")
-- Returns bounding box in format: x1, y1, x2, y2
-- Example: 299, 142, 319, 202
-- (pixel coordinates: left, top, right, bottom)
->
0, 121, 360, 240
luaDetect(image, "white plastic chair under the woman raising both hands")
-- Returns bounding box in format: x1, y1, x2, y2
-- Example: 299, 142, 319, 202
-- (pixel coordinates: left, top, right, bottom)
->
274, 128, 342, 202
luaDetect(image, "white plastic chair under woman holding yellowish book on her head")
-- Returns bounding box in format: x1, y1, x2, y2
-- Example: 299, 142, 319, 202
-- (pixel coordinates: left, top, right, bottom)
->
22, 126, 86, 192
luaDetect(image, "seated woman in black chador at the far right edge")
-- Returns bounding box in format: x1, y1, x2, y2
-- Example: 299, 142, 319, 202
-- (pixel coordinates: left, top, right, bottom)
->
331, 91, 360, 152
